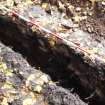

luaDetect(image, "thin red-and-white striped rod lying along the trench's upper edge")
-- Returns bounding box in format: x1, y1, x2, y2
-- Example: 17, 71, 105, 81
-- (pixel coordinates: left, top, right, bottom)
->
0, 5, 105, 62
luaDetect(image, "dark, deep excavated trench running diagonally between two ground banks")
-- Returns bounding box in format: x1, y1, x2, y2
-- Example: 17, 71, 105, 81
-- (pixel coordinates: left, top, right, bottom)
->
0, 17, 105, 105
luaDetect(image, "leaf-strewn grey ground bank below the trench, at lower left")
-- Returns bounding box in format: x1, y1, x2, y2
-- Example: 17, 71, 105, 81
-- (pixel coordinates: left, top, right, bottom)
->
0, 43, 87, 105
